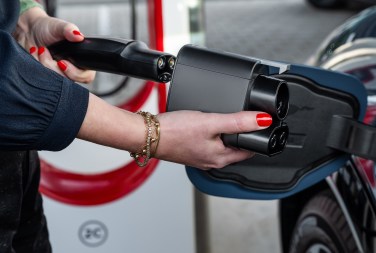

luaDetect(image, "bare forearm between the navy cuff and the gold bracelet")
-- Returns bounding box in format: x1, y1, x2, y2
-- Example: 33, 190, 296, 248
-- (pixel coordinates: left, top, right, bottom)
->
77, 94, 145, 152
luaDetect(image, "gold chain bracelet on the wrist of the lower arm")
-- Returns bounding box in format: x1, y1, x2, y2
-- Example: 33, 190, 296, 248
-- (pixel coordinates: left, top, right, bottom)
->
130, 111, 160, 167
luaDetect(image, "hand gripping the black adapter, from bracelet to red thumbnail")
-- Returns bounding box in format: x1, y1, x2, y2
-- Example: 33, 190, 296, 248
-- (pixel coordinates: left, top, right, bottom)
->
155, 111, 272, 170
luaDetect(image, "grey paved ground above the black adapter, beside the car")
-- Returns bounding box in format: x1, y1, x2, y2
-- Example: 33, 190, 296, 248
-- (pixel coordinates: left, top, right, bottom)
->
205, 0, 354, 63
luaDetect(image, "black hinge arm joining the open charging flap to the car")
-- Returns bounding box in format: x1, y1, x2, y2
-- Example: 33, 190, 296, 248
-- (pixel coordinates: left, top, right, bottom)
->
326, 115, 376, 160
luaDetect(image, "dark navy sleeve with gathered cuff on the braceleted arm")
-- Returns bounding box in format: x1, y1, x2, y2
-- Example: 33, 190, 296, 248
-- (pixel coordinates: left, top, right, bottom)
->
0, 30, 89, 151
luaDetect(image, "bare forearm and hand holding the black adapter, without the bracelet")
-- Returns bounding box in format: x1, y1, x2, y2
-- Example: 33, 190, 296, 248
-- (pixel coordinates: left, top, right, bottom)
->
77, 94, 272, 170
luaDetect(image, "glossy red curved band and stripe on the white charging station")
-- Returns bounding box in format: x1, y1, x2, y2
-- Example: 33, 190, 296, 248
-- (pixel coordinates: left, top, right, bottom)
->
39, 0, 167, 206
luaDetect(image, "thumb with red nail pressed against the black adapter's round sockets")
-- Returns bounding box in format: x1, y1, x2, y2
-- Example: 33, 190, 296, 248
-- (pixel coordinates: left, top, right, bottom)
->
212, 111, 273, 134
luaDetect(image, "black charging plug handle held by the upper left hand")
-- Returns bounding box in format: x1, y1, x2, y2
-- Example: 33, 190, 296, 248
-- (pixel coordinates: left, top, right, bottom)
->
48, 37, 175, 83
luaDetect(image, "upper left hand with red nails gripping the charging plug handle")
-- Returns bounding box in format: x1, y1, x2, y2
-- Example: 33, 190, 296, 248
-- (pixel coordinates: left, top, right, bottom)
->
14, 7, 95, 83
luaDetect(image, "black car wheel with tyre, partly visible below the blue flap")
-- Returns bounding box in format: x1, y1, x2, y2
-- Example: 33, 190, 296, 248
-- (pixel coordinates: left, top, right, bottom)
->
289, 191, 358, 253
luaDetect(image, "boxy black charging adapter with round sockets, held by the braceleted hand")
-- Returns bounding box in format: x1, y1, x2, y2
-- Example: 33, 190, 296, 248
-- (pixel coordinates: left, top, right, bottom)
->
167, 45, 289, 156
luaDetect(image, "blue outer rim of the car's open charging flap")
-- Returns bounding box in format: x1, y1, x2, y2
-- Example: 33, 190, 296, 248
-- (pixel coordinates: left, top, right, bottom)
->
186, 65, 367, 200
